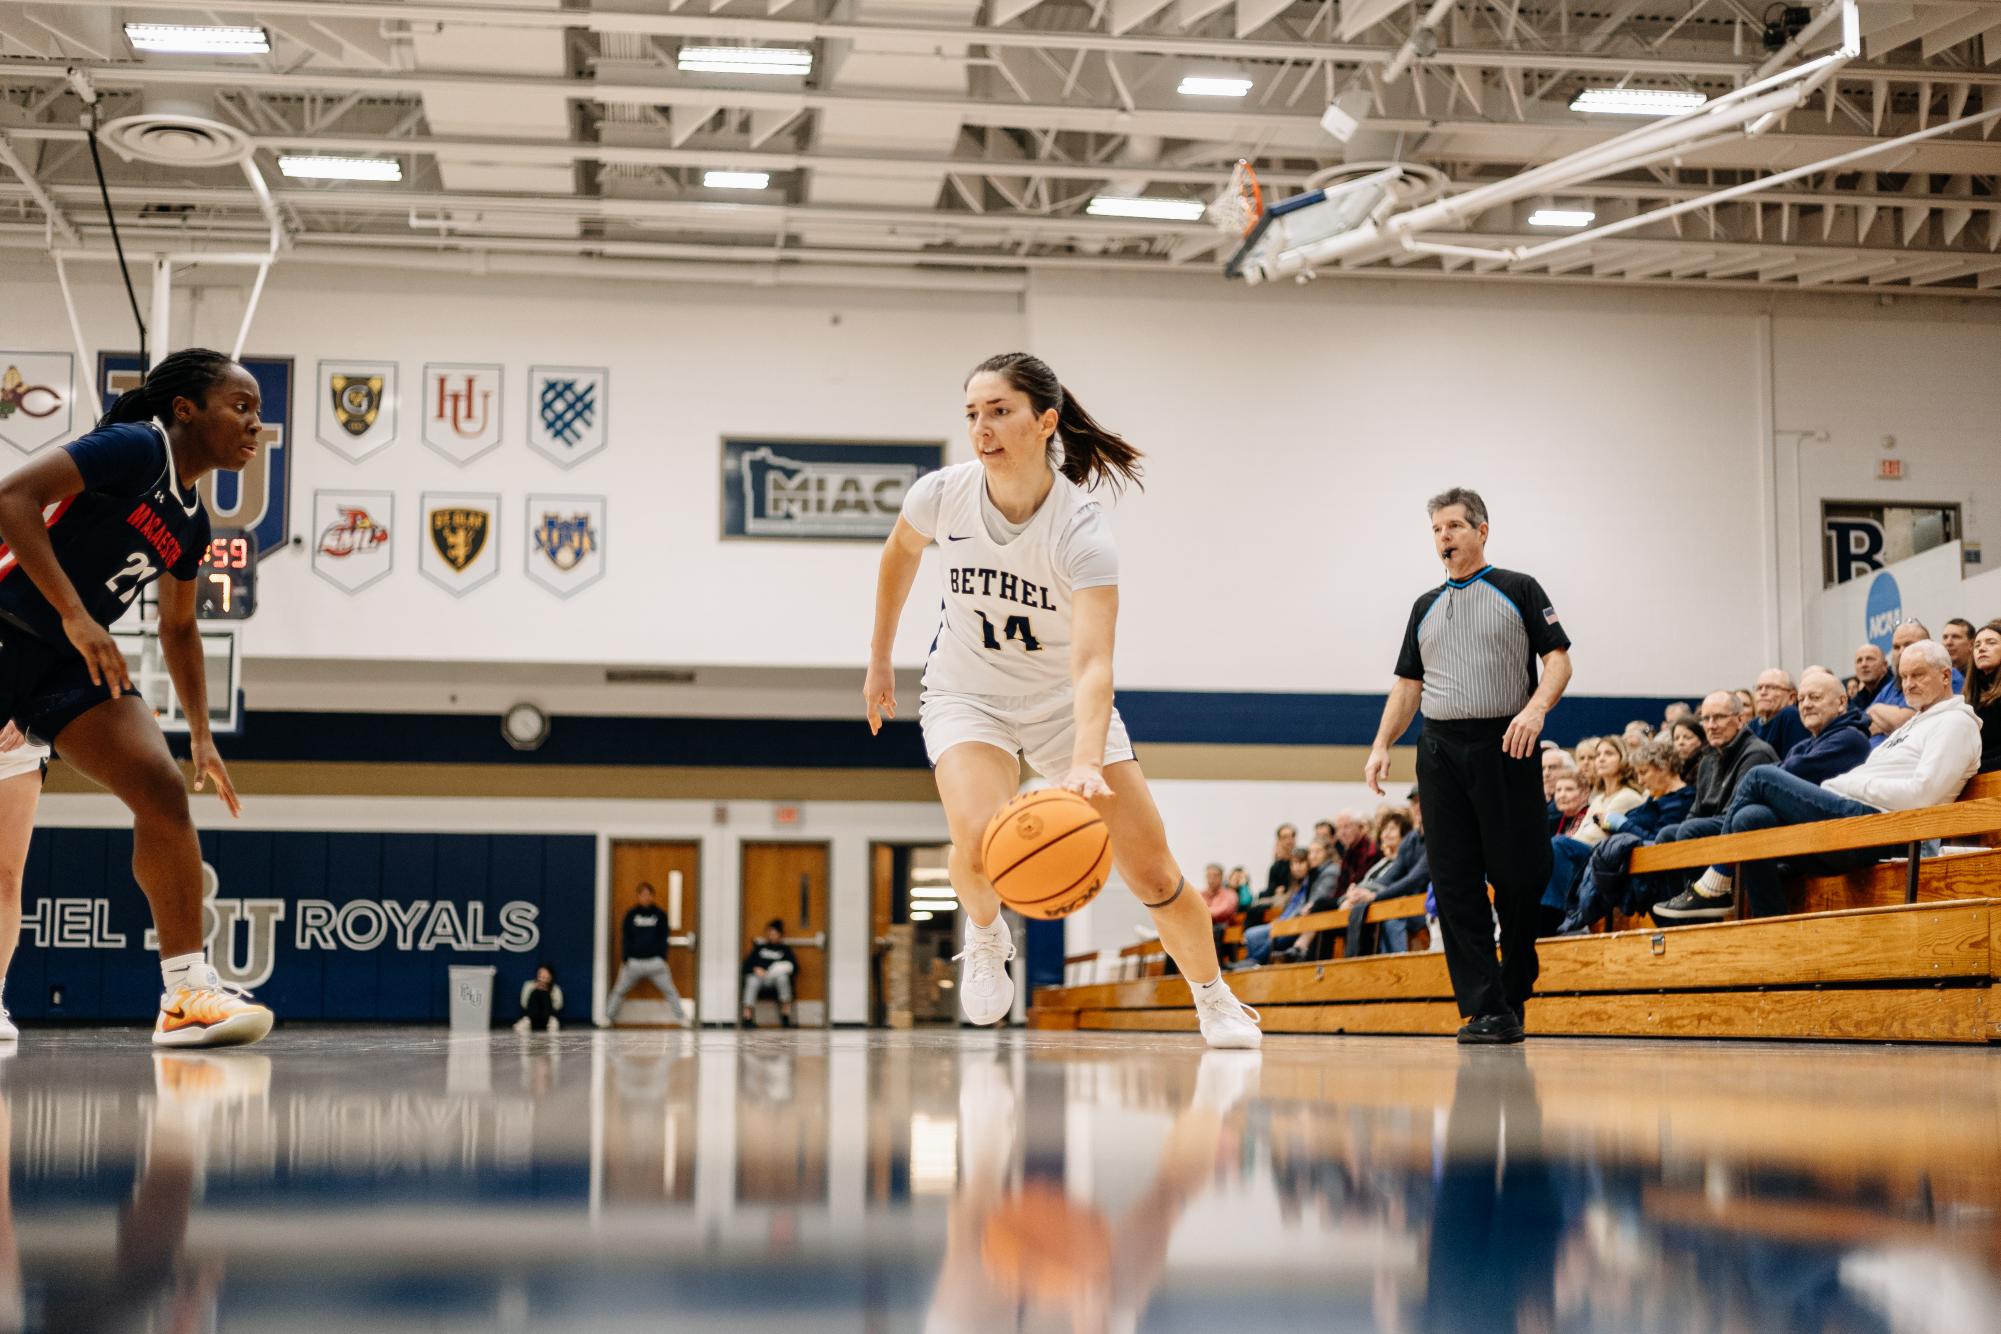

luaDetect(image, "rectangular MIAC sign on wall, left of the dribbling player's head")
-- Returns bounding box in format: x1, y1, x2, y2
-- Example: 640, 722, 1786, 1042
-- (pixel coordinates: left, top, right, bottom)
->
722, 438, 944, 540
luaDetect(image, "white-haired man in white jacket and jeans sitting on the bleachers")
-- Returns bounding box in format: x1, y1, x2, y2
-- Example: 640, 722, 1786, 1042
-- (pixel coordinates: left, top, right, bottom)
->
1655, 640, 1981, 920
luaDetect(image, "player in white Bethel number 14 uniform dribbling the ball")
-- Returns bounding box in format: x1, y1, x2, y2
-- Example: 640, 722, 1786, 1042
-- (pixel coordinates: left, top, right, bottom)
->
862, 352, 1263, 1048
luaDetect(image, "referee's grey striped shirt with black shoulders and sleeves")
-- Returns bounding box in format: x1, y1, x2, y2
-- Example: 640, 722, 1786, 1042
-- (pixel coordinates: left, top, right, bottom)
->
1397, 566, 1571, 722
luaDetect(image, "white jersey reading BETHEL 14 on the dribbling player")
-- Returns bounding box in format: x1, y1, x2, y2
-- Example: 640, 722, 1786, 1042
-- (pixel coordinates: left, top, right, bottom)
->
924, 462, 1097, 696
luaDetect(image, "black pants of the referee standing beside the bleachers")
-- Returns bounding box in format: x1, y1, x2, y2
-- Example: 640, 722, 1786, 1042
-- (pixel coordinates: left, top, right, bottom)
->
1417, 718, 1551, 1018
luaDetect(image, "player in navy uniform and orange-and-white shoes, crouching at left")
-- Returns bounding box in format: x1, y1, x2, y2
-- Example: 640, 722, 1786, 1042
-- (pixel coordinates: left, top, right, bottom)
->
0, 348, 272, 1046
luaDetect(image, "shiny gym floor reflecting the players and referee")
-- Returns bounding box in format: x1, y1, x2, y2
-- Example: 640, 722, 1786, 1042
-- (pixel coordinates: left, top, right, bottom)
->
0, 1028, 2001, 1334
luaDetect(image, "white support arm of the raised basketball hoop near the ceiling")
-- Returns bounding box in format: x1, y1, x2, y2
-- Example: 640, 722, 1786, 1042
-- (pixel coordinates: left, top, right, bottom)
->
1243, 0, 1880, 284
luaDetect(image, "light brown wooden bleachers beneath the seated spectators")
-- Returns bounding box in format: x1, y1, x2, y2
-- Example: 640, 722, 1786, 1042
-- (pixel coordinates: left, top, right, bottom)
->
1031, 760, 2001, 1042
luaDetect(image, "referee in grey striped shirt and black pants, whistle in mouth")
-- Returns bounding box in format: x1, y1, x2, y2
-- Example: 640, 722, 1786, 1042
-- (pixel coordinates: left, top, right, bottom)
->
1363, 486, 1571, 1042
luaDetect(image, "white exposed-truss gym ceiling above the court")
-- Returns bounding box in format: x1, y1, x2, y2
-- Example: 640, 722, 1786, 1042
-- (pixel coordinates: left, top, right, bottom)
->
0, 0, 2001, 296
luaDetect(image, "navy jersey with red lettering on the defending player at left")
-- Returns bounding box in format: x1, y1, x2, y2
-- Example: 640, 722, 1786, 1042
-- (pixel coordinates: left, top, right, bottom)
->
0, 422, 208, 644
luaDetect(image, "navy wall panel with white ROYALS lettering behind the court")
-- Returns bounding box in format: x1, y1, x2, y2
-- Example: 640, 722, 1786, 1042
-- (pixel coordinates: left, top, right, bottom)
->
6, 828, 596, 1022
